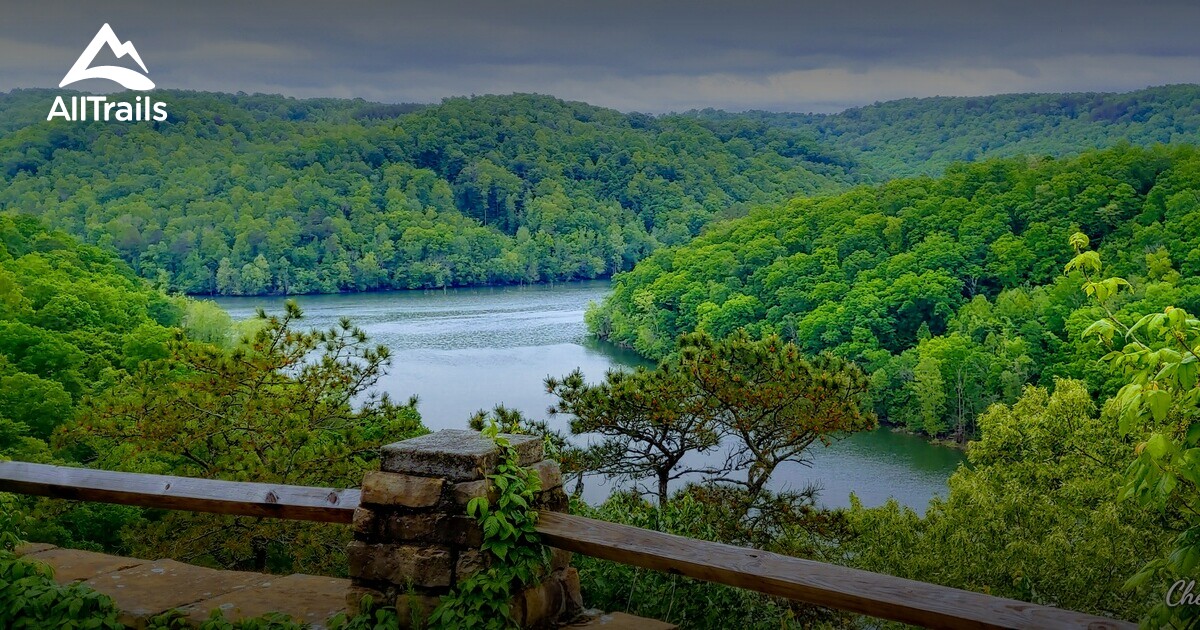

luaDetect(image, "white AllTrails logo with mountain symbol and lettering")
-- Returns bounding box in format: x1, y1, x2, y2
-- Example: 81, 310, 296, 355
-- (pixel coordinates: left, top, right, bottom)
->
46, 24, 167, 122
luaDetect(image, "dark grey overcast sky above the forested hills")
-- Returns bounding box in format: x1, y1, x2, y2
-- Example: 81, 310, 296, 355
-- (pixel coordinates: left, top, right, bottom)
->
0, 0, 1200, 113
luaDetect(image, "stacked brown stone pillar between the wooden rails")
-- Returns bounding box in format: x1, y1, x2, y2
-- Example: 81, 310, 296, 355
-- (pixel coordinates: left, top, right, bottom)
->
347, 430, 582, 628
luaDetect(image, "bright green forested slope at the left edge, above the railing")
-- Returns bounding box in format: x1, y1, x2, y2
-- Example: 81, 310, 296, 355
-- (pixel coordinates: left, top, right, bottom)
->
0, 215, 186, 458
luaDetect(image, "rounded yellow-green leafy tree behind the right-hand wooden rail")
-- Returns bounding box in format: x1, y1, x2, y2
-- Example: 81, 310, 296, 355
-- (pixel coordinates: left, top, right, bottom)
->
839, 380, 1171, 619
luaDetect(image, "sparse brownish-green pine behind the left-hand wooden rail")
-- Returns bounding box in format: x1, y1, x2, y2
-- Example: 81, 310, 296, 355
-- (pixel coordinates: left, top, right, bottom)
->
61, 302, 426, 574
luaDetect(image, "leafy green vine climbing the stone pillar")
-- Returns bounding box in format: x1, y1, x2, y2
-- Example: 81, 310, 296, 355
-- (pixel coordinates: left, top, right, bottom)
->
428, 424, 550, 629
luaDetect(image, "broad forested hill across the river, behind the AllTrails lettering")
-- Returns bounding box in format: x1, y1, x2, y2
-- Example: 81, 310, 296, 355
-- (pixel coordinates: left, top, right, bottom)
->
0, 91, 853, 294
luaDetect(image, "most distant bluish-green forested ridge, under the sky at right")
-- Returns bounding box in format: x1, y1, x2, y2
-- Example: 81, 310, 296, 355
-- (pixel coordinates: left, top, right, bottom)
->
692, 85, 1200, 178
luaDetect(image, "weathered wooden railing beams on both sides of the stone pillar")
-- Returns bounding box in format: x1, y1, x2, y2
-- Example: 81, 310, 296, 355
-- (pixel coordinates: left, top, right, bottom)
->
0, 462, 1135, 630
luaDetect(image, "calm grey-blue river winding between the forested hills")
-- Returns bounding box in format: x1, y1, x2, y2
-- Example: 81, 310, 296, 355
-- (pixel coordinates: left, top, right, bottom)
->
217, 281, 964, 512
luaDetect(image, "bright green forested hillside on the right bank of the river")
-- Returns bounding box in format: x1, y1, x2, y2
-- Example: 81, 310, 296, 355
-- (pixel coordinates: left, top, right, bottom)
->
588, 146, 1200, 437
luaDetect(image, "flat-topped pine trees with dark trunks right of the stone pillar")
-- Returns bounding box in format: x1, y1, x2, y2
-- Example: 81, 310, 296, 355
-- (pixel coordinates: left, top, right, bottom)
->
546, 331, 875, 510
